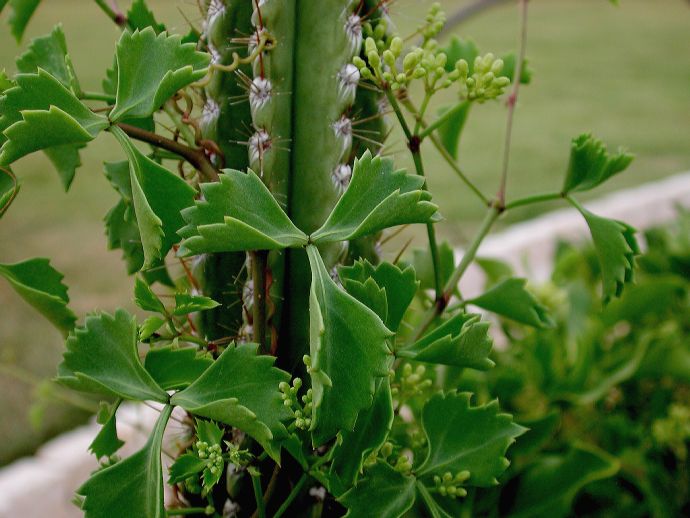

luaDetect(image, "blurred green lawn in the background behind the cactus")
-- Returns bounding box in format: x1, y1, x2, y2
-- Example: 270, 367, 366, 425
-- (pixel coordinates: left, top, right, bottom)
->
0, 0, 690, 464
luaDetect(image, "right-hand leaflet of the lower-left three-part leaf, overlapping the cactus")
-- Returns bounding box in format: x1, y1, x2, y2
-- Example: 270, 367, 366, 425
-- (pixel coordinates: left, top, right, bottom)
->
171, 344, 290, 461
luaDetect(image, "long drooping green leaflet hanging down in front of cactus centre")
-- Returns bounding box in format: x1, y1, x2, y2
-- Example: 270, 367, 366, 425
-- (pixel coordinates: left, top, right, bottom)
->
307, 245, 392, 446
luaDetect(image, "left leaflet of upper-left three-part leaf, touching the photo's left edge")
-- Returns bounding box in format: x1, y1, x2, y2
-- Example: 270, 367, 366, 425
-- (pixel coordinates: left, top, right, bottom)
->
0, 69, 109, 167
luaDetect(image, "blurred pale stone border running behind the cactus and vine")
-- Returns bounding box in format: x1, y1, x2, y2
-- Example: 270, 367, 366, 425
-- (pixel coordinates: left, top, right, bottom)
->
0, 173, 690, 518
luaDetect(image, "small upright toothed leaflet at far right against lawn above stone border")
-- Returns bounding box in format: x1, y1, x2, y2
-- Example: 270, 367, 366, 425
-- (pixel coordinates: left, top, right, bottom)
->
563, 134, 633, 193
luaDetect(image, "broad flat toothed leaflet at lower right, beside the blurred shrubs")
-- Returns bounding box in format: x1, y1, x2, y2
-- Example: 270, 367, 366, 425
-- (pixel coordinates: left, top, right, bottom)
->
415, 392, 525, 487
